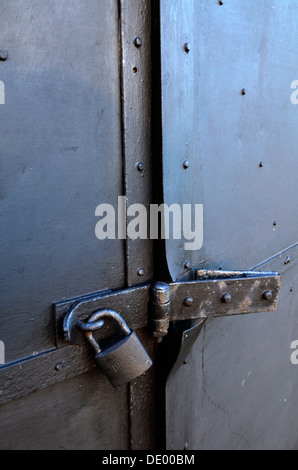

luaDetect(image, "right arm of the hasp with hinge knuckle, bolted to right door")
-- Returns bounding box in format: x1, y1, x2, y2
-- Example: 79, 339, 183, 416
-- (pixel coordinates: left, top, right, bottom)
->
150, 270, 281, 339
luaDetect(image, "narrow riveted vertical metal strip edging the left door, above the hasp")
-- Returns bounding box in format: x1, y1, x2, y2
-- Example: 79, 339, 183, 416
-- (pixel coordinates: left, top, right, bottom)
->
120, 0, 154, 286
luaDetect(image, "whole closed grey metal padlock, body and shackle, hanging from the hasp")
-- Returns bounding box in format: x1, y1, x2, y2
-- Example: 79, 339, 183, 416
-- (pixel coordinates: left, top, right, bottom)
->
77, 310, 152, 388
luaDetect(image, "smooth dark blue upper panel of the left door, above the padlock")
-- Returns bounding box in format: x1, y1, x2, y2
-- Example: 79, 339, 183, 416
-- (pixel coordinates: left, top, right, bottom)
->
0, 0, 125, 362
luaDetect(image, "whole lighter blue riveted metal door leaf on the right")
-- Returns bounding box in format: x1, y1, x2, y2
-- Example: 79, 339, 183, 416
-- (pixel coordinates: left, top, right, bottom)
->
161, 0, 298, 449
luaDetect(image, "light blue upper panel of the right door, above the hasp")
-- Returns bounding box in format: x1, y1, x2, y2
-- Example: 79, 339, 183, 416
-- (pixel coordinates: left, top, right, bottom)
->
161, 0, 298, 279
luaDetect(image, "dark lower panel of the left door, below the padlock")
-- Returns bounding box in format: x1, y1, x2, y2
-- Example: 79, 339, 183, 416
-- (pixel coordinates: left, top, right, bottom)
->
1, 370, 129, 450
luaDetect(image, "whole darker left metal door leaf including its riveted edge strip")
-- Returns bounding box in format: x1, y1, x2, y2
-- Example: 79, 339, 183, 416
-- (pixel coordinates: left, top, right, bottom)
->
0, 0, 154, 449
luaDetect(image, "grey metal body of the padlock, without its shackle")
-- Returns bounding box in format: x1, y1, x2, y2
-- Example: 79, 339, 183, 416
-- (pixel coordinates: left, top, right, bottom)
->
95, 332, 152, 388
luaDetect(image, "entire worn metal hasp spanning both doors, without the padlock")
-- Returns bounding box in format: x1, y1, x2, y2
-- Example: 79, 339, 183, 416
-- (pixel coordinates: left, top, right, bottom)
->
56, 270, 281, 344
